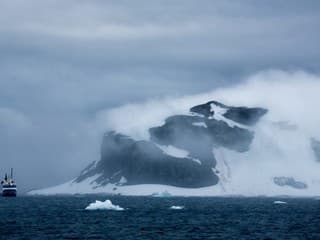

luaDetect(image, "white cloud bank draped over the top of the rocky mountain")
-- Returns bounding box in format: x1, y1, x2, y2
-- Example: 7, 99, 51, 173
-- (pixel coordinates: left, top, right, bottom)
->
96, 70, 320, 140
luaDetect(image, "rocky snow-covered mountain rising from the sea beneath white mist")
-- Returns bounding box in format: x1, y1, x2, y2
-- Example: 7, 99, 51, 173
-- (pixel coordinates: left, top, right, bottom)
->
29, 101, 320, 196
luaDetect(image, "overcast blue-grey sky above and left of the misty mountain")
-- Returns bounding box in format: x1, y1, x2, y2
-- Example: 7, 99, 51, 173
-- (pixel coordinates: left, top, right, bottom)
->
0, 0, 320, 191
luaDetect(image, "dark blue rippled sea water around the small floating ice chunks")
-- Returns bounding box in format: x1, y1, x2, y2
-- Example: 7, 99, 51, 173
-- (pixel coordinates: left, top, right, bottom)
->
0, 196, 320, 240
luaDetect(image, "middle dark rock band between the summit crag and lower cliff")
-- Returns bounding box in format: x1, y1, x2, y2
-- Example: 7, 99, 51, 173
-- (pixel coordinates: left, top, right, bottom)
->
150, 116, 254, 155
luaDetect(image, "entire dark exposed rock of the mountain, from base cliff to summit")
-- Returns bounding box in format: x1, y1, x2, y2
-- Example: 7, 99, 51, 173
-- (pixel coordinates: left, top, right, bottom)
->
76, 102, 267, 188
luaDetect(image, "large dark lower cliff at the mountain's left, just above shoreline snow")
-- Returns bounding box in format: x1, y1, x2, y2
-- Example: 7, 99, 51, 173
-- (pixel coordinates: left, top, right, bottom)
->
77, 132, 218, 187
